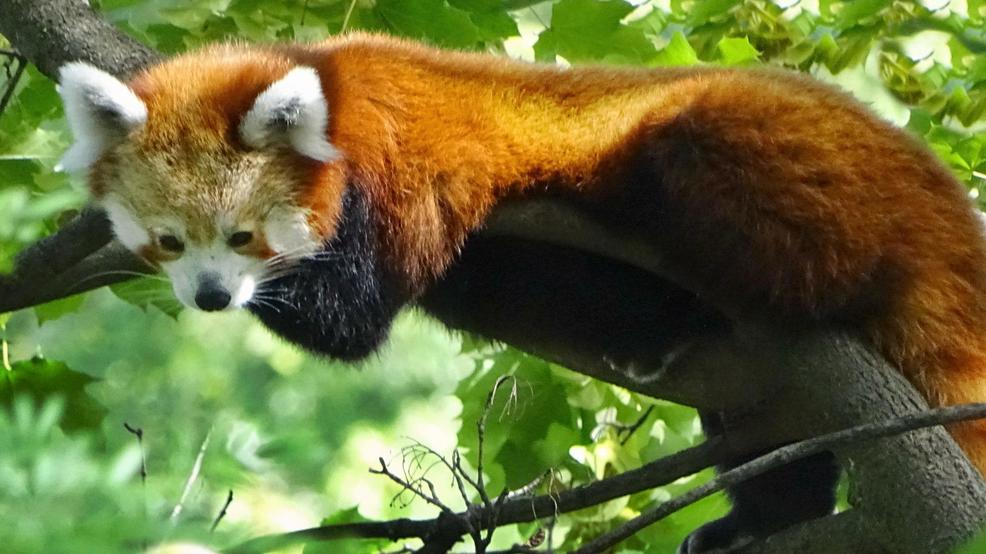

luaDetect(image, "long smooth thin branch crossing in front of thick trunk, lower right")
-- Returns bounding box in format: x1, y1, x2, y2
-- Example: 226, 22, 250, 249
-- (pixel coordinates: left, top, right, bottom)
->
572, 403, 986, 554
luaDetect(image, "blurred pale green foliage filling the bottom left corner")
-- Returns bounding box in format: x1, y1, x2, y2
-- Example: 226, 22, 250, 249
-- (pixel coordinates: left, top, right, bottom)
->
0, 396, 204, 554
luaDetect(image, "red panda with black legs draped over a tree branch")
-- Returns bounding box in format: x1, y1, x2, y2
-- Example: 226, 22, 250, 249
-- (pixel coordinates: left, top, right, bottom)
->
55, 35, 986, 552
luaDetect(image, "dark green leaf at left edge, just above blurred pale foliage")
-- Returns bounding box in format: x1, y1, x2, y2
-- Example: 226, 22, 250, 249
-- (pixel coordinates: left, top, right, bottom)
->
0, 357, 106, 430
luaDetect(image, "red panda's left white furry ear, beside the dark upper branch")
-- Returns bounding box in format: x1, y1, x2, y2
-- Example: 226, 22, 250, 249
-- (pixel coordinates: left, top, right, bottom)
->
55, 62, 147, 171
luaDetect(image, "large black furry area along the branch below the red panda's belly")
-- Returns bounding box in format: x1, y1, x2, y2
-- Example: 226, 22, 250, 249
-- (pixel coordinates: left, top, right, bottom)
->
419, 237, 728, 368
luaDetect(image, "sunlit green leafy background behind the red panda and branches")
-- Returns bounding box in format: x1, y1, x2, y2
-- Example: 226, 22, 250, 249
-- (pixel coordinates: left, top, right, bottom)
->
0, 0, 986, 553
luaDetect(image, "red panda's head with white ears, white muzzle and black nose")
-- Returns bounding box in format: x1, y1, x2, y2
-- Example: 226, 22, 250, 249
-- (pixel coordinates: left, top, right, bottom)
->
60, 46, 339, 311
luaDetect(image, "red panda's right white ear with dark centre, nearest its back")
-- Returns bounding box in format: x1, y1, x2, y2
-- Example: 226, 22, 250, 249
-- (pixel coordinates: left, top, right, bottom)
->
240, 67, 339, 162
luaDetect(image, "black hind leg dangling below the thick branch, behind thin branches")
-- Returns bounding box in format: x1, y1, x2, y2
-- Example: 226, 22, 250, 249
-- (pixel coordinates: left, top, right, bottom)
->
678, 413, 840, 554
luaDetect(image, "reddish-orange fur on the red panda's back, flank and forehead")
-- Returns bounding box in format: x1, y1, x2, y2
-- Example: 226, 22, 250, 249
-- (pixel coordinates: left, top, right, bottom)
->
127, 35, 986, 471
